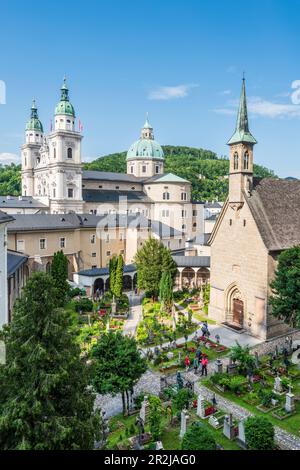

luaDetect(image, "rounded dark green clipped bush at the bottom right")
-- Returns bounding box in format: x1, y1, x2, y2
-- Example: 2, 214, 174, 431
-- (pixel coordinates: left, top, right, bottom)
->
245, 416, 274, 450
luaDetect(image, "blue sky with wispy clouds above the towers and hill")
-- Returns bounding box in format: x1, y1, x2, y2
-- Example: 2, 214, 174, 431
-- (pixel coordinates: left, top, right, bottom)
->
0, 0, 300, 177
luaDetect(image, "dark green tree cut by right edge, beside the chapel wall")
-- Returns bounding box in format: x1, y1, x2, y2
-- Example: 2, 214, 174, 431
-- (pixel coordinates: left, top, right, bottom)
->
270, 246, 300, 328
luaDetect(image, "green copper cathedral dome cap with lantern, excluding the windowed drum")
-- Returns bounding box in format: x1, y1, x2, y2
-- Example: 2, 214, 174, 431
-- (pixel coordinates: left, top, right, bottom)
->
127, 116, 164, 160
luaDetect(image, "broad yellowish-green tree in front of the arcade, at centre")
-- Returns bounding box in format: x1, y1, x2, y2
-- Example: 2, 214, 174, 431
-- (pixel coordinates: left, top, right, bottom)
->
135, 237, 176, 300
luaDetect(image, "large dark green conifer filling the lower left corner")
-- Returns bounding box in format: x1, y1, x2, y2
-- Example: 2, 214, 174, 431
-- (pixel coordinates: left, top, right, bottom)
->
0, 273, 101, 450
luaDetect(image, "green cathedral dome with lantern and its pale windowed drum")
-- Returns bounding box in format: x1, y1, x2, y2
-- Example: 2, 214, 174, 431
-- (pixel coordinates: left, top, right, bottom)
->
127, 115, 164, 179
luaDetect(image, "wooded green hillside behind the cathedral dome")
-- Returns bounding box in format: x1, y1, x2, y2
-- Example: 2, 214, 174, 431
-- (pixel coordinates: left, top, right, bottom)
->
84, 145, 275, 201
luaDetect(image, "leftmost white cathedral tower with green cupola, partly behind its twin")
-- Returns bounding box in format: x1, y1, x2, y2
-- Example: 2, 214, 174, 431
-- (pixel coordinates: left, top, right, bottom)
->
21, 100, 44, 196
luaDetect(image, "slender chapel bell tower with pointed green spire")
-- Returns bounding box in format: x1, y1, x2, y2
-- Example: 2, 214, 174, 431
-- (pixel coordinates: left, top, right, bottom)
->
227, 78, 257, 203
